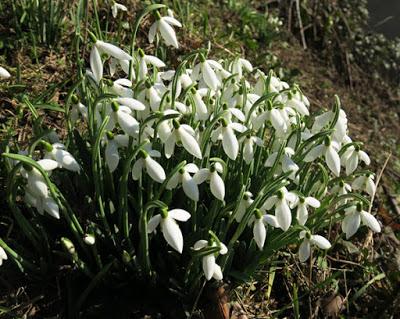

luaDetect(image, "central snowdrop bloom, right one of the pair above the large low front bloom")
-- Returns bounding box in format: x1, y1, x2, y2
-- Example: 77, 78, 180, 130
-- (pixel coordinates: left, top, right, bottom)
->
193, 162, 225, 201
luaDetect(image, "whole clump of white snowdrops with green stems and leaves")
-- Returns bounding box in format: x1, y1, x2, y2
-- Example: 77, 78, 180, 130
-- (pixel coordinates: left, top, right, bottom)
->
0, 1, 380, 308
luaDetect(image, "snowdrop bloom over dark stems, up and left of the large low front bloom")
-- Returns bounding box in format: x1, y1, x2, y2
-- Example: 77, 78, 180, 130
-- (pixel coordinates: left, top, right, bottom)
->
132, 149, 166, 183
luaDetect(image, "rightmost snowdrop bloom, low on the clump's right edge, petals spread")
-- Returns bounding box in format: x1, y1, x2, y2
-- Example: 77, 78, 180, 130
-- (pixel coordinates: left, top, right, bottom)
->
342, 204, 381, 239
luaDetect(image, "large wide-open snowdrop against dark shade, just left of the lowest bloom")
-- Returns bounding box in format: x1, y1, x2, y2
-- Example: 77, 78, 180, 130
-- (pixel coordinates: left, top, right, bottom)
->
147, 209, 190, 254
